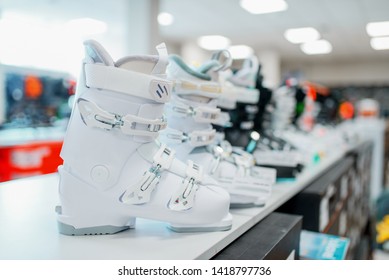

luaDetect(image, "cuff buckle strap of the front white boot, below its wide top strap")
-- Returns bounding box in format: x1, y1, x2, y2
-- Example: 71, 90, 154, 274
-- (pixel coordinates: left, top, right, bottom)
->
77, 98, 167, 137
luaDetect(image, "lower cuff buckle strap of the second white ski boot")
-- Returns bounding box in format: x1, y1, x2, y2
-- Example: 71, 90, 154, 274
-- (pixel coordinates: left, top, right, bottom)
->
161, 127, 216, 147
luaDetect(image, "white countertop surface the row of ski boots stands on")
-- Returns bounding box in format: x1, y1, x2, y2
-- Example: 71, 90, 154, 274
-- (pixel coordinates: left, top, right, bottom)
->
0, 144, 360, 260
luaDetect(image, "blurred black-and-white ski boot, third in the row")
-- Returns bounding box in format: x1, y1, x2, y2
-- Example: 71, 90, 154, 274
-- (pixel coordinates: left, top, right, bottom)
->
215, 56, 303, 180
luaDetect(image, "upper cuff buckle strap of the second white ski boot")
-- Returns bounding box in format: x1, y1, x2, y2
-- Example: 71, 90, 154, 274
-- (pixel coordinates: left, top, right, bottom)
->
166, 101, 221, 123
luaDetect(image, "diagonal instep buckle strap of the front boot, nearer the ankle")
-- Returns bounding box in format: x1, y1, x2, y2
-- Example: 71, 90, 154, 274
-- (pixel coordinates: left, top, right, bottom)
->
119, 144, 175, 205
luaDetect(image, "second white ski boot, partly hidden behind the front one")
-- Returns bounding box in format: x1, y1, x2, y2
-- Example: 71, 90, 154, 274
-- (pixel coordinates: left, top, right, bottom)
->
161, 55, 275, 207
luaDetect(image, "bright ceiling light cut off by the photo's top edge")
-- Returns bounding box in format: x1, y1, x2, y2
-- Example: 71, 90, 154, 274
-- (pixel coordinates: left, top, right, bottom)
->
240, 0, 288, 14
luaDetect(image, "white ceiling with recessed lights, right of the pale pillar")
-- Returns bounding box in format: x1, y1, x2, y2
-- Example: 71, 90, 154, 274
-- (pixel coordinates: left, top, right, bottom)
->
161, 0, 389, 60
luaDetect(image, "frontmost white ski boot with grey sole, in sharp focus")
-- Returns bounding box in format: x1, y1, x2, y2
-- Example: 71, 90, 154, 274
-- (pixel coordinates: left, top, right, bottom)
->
57, 40, 232, 235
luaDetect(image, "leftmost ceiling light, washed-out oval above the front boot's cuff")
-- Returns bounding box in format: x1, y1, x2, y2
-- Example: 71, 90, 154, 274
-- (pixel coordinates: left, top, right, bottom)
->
66, 18, 107, 36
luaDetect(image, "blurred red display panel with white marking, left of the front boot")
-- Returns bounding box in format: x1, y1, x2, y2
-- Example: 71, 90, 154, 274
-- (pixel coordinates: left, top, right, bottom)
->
0, 141, 63, 182
